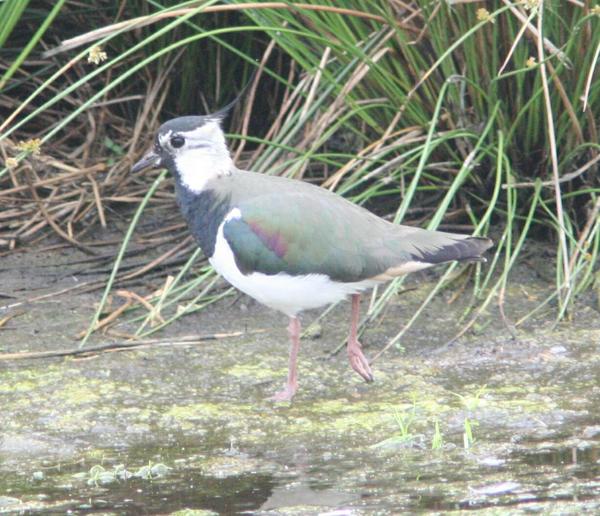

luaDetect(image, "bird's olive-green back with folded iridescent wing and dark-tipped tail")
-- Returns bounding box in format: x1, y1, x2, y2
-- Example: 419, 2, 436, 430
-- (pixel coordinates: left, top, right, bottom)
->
217, 170, 491, 282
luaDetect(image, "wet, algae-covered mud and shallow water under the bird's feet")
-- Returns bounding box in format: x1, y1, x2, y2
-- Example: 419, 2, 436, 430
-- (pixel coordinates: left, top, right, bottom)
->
0, 249, 600, 515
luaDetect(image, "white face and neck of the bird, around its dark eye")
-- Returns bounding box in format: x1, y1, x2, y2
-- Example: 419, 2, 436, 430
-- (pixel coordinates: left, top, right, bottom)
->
158, 120, 233, 193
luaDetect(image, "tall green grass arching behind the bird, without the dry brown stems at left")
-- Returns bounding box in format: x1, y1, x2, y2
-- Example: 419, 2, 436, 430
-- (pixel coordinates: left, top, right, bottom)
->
0, 0, 600, 346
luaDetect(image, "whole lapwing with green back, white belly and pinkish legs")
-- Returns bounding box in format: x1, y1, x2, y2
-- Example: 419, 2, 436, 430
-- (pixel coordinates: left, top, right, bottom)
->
131, 110, 492, 402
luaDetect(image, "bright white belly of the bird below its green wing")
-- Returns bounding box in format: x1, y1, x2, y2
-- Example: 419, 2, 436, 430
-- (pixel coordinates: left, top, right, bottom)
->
209, 222, 375, 316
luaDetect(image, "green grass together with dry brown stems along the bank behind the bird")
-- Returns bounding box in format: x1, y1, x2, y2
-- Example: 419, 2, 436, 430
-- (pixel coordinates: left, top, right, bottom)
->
0, 0, 600, 343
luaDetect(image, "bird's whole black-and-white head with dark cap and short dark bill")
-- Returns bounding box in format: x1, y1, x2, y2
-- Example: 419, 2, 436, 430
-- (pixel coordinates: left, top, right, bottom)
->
131, 112, 233, 192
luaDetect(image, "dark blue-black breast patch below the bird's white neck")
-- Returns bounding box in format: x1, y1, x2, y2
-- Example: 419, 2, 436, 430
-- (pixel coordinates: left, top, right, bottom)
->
175, 181, 231, 258
